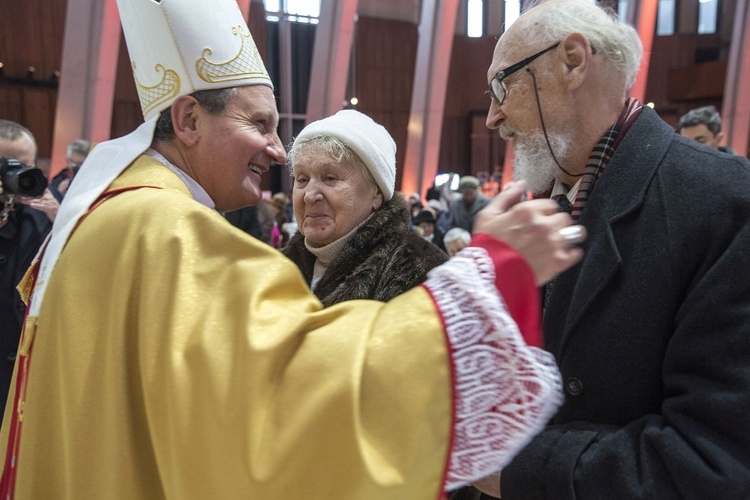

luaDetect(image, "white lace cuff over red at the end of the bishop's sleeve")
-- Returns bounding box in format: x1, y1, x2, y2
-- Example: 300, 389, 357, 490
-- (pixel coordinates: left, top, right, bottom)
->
424, 247, 563, 491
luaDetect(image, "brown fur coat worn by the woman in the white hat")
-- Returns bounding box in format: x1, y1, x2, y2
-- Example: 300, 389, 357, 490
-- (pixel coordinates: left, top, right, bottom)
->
283, 193, 448, 307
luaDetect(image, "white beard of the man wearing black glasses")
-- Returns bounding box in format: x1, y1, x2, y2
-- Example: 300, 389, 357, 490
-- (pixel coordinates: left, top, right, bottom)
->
513, 131, 570, 194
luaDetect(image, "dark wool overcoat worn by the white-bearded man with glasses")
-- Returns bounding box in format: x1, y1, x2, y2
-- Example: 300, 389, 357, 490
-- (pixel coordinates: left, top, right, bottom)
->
464, 107, 750, 500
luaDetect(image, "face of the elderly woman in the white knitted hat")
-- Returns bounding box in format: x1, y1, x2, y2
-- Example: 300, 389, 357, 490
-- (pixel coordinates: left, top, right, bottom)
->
292, 144, 383, 247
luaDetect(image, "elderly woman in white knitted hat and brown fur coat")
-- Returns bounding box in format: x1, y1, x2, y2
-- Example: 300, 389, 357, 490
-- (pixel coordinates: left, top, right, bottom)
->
283, 110, 448, 306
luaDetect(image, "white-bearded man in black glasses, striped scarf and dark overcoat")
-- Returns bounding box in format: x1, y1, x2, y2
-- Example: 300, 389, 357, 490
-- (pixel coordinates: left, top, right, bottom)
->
464, 0, 750, 499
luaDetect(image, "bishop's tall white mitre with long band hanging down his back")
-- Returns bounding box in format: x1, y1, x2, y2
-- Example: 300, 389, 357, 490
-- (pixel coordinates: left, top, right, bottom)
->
29, 0, 273, 316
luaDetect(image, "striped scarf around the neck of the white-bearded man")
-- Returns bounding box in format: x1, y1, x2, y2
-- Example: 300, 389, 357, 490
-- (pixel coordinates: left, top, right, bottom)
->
570, 97, 643, 223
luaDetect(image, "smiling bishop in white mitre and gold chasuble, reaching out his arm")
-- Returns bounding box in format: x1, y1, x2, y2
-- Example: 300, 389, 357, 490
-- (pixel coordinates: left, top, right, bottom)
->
0, 0, 584, 500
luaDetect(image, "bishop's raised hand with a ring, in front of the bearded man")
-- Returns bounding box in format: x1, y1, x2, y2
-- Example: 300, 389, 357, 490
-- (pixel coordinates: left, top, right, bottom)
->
474, 182, 586, 285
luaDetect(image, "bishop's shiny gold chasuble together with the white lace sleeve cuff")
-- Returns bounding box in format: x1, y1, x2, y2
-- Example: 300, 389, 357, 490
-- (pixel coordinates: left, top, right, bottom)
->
0, 156, 559, 500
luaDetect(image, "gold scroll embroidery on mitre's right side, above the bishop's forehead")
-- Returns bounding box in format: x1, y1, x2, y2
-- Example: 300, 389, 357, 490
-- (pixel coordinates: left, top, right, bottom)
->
195, 26, 270, 83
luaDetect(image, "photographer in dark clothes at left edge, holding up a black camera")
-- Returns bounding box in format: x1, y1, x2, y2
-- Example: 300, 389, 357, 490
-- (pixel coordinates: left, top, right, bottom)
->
0, 120, 60, 420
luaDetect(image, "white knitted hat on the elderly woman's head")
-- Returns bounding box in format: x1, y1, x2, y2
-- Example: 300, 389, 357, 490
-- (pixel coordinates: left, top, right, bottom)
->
292, 109, 396, 200
